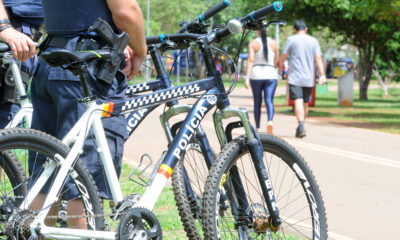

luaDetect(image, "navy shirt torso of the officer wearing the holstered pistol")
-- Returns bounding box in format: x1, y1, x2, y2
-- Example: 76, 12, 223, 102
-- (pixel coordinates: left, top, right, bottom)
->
42, 0, 114, 35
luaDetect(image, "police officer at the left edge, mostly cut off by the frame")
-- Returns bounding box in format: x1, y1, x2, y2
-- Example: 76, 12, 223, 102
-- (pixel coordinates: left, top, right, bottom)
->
0, 0, 43, 128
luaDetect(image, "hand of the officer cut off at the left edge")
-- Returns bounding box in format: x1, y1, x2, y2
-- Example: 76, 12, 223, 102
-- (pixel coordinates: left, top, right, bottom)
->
0, 28, 36, 61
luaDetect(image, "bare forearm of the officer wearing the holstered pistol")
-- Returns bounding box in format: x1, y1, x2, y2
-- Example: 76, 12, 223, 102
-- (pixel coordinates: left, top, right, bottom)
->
107, 0, 147, 61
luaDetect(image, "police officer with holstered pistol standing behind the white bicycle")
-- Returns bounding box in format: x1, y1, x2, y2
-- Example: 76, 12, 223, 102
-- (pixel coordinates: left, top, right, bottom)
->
29, 0, 147, 226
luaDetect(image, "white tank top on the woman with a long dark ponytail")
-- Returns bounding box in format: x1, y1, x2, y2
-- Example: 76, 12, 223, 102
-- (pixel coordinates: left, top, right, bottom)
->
249, 37, 278, 80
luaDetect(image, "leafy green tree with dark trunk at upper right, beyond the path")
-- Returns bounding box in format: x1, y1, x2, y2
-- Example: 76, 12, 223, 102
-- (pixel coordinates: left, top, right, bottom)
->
249, 0, 400, 100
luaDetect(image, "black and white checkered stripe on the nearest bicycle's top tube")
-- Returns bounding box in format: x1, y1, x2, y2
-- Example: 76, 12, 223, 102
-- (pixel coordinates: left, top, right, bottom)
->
122, 84, 200, 111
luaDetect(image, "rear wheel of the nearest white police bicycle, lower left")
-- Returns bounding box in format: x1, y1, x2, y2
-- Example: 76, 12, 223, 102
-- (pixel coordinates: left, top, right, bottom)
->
0, 129, 104, 239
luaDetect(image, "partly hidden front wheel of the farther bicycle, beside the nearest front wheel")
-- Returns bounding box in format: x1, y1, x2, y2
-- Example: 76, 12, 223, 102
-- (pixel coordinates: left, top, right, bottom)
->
172, 143, 215, 240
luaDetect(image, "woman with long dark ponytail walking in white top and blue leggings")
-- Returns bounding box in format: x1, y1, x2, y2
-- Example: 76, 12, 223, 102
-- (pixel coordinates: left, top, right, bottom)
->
245, 29, 279, 134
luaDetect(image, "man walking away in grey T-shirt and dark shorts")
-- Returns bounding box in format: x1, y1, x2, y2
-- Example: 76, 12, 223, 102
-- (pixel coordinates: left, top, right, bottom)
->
279, 20, 326, 138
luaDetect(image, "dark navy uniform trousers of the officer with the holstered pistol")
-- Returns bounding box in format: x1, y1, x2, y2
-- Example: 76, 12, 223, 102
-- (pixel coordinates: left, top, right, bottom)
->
29, 37, 128, 199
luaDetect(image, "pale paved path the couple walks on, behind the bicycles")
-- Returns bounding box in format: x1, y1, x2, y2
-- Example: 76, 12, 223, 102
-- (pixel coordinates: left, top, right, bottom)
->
124, 85, 400, 240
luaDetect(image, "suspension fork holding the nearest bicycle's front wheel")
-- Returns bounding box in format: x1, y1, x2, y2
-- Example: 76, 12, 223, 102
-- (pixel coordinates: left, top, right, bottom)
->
214, 108, 281, 231
